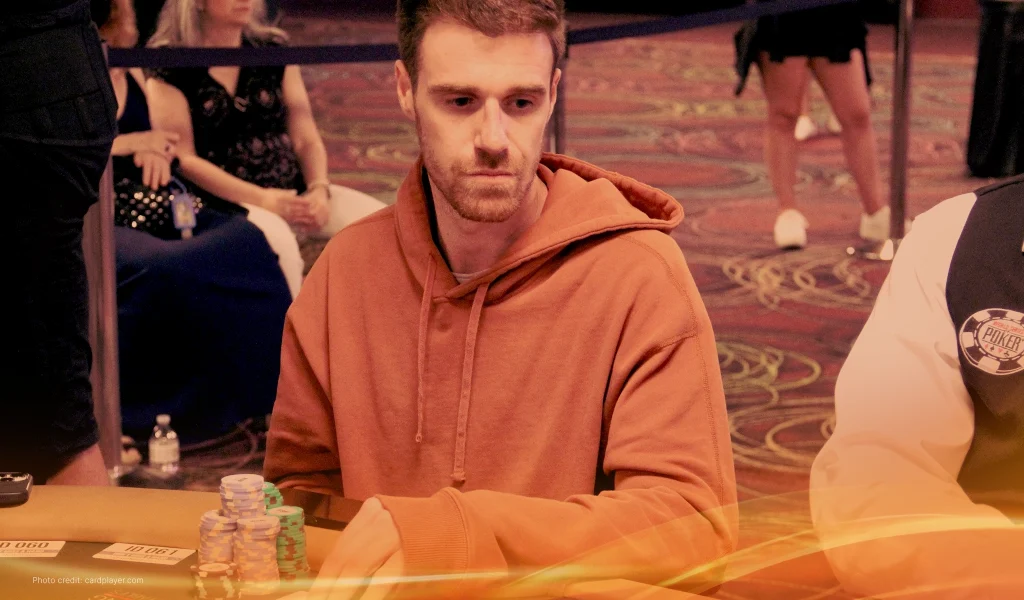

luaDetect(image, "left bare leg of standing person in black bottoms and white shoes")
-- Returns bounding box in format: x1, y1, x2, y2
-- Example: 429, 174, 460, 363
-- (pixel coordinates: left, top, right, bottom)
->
760, 53, 807, 210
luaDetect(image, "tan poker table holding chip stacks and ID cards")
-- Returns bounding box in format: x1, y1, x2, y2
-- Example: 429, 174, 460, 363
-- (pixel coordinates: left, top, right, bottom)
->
0, 485, 716, 600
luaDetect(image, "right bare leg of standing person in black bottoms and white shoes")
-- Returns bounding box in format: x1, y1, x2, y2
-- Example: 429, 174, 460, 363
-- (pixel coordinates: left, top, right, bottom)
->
811, 50, 886, 215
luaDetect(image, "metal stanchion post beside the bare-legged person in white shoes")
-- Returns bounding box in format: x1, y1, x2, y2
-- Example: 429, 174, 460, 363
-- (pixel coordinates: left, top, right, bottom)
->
850, 0, 913, 260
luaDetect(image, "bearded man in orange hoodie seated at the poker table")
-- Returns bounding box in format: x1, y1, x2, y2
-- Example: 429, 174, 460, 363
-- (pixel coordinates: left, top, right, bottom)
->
265, 0, 736, 598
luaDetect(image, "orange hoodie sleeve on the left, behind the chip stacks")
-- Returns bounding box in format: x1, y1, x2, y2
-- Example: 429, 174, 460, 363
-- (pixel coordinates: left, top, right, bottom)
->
263, 244, 342, 496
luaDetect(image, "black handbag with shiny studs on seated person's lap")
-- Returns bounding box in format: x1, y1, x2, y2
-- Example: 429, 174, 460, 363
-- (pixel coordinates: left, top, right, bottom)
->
114, 173, 203, 240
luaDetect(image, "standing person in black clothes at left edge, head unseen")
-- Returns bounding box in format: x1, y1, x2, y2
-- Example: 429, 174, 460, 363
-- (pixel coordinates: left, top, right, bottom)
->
0, 0, 117, 485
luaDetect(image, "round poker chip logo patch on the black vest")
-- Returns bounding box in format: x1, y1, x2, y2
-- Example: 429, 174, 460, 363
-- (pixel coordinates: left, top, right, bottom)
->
959, 308, 1024, 375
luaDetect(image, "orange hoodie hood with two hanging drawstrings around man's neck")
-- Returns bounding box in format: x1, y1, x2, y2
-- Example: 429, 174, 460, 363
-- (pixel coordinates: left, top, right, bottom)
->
395, 154, 683, 484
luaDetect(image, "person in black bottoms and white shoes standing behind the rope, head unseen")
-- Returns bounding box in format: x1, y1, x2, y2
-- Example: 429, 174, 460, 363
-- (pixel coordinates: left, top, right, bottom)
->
736, 4, 890, 249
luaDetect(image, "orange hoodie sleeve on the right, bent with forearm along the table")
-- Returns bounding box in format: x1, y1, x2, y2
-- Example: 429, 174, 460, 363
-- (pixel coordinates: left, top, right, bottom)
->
380, 237, 737, 593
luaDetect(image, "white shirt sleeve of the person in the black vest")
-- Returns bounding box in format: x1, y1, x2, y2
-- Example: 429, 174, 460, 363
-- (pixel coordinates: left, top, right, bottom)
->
810, 194, 1024, 600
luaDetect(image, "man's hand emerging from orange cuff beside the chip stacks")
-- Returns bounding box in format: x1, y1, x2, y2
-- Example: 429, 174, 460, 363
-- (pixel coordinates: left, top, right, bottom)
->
309, 498, 404, 600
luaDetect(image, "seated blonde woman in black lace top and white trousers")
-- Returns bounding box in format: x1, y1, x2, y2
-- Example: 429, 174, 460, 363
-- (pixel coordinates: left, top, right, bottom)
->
147, 0, 385, 292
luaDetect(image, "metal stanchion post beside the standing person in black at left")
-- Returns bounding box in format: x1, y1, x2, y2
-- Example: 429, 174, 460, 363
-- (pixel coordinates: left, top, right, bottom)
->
82, 48, 126, 481
